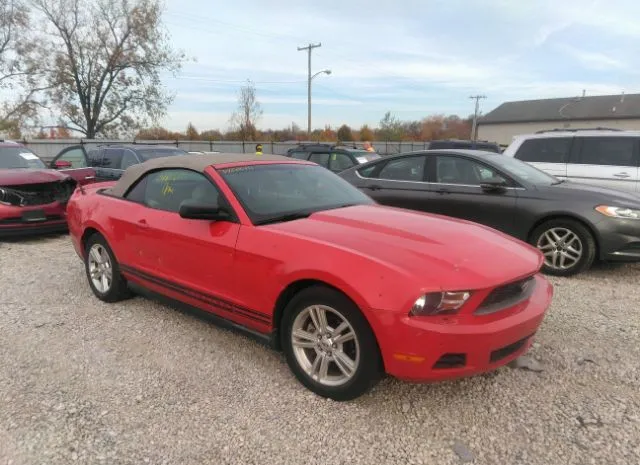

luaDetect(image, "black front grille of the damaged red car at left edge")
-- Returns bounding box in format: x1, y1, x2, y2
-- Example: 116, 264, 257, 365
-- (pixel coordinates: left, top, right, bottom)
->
0, 179, 76, 207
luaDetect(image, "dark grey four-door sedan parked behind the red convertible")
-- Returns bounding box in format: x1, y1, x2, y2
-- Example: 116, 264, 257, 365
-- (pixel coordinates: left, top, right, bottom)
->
340, 150, 640, 276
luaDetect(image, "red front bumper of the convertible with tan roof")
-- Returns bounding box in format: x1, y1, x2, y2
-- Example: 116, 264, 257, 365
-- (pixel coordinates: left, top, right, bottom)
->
375, 275, 553, 382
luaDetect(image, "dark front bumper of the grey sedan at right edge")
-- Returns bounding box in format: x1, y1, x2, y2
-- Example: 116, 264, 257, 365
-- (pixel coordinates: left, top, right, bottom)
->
596, 218, 640, 262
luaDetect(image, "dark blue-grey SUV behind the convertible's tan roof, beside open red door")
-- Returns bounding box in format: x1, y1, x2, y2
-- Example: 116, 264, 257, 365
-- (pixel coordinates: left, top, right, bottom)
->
50, 144, 187, 181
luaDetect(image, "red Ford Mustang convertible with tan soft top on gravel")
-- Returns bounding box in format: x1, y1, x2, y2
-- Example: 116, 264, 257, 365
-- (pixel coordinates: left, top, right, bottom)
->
68, 154, 553, 400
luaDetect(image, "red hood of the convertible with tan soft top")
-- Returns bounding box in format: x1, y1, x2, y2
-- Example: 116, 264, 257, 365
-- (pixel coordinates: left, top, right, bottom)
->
266, 205, 542, 290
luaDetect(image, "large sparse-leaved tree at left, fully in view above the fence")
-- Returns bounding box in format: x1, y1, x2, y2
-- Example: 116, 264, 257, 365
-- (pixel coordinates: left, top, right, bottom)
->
32, 0, 184, 138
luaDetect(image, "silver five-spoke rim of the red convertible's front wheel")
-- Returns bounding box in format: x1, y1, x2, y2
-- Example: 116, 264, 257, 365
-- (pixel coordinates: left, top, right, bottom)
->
291, 305, 360, 387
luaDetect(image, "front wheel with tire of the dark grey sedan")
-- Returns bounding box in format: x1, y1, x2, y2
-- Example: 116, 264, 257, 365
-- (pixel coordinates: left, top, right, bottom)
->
530, 218, 596, 276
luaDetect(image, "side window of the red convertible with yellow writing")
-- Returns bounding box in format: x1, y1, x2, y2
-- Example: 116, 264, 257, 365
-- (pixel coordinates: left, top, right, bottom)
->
125, 169, 220, 213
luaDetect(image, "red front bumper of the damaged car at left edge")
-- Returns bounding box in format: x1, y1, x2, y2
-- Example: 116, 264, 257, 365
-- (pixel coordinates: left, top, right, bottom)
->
0, 202, 68, 238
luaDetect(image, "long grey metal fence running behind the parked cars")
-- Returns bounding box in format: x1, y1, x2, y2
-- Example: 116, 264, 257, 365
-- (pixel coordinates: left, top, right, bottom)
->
20, 139, 428, 161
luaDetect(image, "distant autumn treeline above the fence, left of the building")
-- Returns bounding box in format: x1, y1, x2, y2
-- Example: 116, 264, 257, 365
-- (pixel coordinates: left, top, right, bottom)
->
136, 112, 471, 142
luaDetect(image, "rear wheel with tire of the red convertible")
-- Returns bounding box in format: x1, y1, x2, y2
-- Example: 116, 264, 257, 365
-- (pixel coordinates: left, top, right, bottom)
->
84, 234, 131, 303
